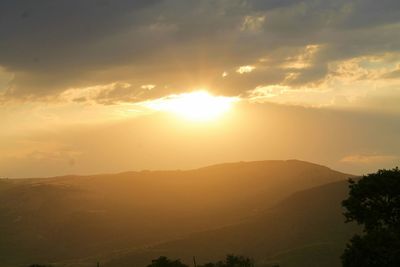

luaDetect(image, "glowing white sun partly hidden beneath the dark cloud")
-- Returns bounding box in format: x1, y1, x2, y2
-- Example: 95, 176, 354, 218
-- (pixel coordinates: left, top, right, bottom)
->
144, 90, 238, 122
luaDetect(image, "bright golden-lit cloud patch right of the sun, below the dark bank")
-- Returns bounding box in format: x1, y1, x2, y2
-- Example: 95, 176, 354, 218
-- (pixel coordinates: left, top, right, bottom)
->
235, 52, 400, 114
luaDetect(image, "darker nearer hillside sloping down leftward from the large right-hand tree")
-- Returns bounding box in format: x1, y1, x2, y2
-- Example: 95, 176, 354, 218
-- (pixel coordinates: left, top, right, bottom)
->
105, 181, 358, 267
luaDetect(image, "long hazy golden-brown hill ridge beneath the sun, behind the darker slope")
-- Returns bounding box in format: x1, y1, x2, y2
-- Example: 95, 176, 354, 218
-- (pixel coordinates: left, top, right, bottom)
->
0, 160, 349, 266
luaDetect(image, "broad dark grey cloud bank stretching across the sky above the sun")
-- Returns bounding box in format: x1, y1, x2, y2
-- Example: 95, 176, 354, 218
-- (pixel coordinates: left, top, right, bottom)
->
0, 0, 400, 101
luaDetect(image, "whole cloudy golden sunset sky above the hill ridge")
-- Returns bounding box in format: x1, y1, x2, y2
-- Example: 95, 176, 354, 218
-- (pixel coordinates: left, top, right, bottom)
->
0, 0, 400, 178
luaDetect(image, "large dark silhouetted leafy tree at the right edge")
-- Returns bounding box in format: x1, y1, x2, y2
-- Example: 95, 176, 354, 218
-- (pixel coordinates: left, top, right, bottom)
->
342, 168, 400, 267
